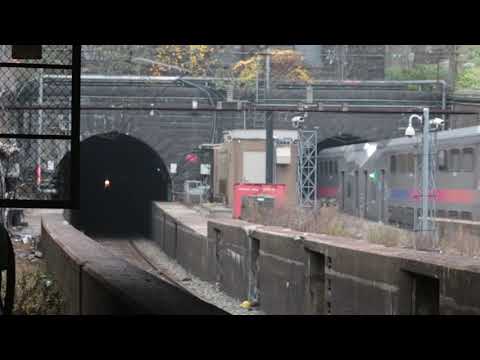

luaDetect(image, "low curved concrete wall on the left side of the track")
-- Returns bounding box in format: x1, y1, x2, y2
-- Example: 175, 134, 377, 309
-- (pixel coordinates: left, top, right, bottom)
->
41, 215, 226, 315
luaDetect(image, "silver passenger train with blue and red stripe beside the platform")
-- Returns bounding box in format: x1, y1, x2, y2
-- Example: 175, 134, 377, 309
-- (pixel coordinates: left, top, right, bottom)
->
317, 126, 480, 230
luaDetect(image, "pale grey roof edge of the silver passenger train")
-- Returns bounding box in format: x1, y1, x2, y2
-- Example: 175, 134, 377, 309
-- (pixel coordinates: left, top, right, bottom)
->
320, 126, 480, 155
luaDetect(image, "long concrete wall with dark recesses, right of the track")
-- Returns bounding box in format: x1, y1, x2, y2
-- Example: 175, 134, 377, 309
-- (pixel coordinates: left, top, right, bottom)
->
153, 203, 480, 315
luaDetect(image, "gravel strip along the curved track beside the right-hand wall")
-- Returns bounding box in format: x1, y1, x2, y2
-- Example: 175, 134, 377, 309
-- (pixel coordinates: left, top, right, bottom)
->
129, 238, 265, 315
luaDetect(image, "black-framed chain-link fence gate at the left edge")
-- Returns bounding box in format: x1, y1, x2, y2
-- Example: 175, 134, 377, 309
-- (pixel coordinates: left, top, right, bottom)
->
0, 45, 81, 210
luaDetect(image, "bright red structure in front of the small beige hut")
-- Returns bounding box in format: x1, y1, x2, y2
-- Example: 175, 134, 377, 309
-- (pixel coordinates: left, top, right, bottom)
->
233, 184, 287, 219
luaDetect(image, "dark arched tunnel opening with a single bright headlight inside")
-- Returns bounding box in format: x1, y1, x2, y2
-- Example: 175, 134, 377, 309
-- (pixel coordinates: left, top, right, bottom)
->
56, 132, 170, 236
